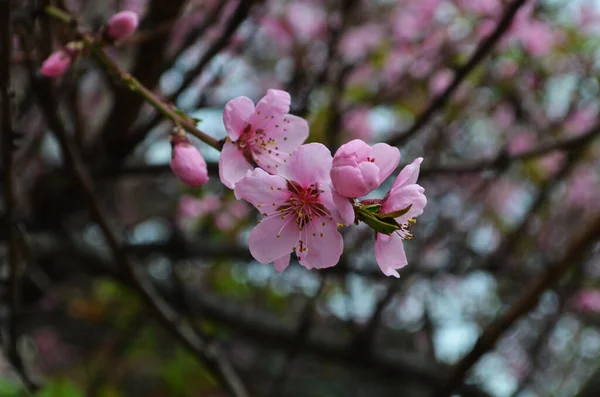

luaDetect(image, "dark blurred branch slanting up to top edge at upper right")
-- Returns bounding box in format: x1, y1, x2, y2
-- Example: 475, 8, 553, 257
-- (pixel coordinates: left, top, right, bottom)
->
387, 0, 527, 146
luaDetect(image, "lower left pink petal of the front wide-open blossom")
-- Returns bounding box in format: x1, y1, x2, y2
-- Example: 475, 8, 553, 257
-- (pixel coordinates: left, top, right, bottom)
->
248, 215, 299, 264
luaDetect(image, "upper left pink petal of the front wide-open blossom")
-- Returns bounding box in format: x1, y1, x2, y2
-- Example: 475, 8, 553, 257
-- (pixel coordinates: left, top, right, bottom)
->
233, 168, 289, 214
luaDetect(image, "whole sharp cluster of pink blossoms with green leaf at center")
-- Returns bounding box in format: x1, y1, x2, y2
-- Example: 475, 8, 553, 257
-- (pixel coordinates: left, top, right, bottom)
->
219, 90, 427, 277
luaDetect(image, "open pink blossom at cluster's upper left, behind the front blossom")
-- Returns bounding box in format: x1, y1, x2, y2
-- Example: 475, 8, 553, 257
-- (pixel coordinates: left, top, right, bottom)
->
219, 90, 308, 189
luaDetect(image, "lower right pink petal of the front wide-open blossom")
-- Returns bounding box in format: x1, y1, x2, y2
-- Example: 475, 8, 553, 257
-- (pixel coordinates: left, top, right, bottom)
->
296, 219, 344, 269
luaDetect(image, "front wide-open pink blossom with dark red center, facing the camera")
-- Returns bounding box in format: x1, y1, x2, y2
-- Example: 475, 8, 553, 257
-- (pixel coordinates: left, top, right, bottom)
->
234, 143, 343, 272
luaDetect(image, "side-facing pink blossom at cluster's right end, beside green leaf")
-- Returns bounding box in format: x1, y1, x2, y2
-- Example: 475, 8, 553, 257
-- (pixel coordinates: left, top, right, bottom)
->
375, 157, 427, 278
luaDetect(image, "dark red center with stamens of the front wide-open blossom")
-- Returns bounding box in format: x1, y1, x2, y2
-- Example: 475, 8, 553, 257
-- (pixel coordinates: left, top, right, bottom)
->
277, 181, 331, 230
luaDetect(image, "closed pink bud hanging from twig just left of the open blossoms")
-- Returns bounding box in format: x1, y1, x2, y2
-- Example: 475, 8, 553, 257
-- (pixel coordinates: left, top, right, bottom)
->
170, 135, 208, 186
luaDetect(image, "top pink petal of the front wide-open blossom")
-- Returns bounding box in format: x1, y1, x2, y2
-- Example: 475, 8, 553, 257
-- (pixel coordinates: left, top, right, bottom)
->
279, 143, 332, 187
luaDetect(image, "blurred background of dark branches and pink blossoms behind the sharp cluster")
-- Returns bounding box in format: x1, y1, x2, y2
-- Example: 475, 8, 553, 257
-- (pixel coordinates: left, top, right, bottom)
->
0, 0, 600, 397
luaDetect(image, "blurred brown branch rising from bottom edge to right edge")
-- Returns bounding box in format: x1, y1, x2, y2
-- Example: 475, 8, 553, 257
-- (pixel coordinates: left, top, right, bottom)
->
433, 213, 600, 397
